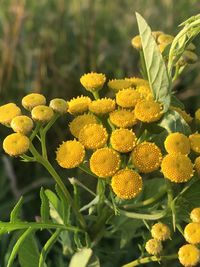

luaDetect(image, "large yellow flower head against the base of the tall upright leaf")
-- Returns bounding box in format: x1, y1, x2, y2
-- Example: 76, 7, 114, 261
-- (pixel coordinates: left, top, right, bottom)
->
135, 100, 163, 122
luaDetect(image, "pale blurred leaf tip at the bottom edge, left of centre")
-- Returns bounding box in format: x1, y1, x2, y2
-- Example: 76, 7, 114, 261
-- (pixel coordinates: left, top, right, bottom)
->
69, 248, 93, 267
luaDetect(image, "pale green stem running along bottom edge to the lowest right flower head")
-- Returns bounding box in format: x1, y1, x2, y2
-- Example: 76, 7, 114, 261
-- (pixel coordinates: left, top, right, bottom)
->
122, 254, 178, 267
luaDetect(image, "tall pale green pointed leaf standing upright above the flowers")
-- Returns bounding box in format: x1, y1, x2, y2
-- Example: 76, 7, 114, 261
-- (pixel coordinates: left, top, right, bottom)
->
136, 13, 170, 112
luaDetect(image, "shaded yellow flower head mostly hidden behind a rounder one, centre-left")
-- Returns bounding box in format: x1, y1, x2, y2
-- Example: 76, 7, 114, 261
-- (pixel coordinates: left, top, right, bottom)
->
69, 114, 97, 138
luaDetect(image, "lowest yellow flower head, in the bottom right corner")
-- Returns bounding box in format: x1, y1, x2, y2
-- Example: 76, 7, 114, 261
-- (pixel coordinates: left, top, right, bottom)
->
178, 244, 200, 267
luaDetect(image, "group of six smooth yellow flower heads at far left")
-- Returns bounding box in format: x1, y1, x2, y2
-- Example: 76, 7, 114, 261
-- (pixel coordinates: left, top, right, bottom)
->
0, 93, 68, 157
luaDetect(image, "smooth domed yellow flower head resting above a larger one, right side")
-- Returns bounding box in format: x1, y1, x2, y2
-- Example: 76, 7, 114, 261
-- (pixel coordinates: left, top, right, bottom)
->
164, 132, 190, 155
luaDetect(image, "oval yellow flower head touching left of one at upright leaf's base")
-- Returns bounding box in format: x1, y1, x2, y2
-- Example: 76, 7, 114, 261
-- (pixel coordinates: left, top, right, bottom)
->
109, 109, 137, 128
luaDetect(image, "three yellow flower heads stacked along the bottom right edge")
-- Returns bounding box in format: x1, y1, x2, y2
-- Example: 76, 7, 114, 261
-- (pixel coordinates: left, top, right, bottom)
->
178, 207, 200, 267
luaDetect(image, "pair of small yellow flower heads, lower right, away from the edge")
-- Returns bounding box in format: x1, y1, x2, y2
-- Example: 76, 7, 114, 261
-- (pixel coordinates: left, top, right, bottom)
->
145, 222, 171, 256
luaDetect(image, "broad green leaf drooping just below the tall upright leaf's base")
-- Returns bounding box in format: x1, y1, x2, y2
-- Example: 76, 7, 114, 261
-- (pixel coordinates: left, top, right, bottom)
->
158, 110, 191, 135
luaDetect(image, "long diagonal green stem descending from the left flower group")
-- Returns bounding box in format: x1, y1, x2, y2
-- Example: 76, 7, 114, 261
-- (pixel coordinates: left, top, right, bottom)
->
30, 144, 86, 229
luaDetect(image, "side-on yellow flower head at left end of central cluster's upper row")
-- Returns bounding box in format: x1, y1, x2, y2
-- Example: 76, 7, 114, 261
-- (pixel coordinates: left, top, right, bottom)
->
67, 96, 91, 115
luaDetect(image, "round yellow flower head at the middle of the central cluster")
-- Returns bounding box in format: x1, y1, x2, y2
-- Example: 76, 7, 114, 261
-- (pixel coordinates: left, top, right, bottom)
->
110, 129, 137, 153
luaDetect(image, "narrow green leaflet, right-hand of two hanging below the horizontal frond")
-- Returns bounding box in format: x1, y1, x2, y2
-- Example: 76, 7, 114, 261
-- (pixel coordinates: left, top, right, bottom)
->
39, 229, 61, 267
